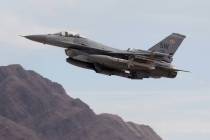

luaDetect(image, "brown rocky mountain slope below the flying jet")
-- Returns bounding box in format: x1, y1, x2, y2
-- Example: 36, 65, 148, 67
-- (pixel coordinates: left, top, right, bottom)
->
0, 65, 161, 140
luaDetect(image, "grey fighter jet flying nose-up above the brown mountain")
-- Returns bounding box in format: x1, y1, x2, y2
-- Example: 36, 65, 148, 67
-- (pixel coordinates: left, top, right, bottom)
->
24, 32, 187, 79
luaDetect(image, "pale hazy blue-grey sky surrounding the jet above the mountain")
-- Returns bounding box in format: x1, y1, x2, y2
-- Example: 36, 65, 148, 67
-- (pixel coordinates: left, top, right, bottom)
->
0, 0, 210, 140
